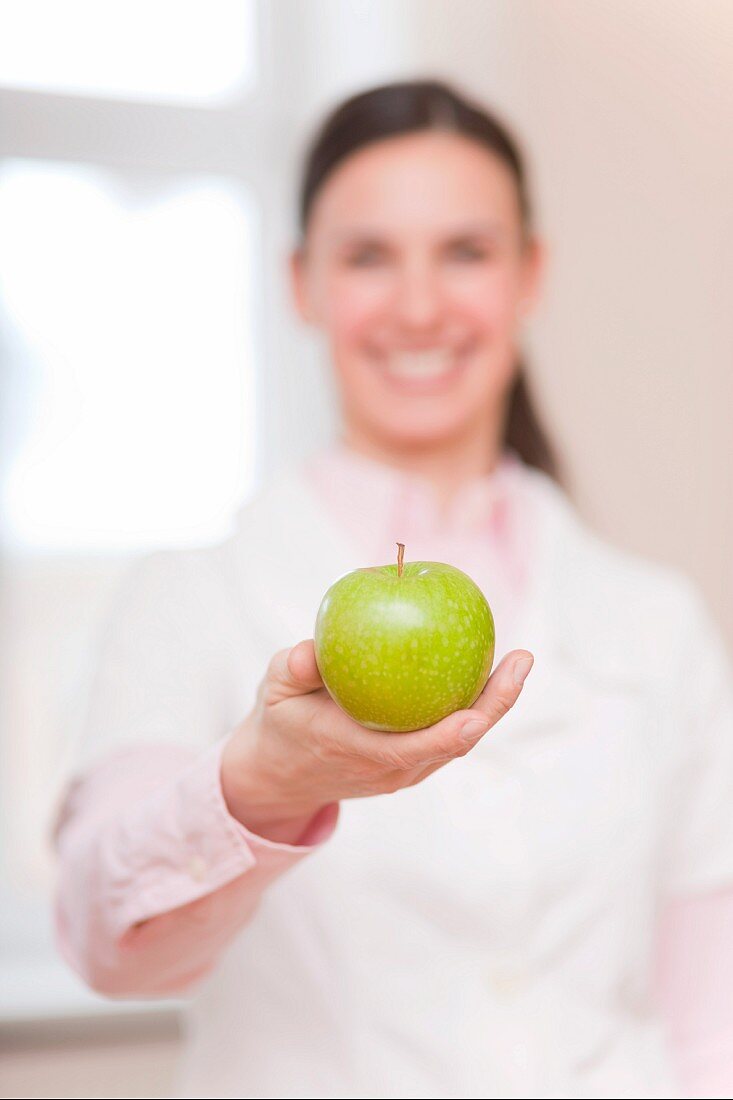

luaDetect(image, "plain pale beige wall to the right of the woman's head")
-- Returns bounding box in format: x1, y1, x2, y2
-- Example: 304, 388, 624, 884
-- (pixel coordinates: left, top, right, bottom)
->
411, 0, 733, 641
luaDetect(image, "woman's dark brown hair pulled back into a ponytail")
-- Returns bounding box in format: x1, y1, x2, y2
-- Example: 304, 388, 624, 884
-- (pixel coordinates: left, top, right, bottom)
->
299, 80, 559, 481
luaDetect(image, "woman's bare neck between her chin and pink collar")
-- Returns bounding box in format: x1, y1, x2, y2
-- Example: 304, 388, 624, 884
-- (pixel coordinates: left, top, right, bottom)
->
341, 418, 502, 508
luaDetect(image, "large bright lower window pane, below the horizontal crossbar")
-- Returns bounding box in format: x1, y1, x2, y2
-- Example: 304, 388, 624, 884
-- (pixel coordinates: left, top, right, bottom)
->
0, 161, 255, 552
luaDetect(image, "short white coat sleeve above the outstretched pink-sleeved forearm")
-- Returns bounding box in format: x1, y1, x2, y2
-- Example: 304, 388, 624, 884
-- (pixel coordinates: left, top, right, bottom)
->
72, 550, 239, 771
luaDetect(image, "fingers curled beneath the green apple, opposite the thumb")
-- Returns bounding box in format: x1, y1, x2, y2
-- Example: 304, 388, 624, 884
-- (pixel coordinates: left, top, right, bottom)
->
370, 649, 534, 768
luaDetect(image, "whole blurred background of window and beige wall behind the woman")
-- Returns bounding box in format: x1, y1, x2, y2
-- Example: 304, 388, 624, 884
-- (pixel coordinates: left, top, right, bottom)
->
0, 0, 733, 1097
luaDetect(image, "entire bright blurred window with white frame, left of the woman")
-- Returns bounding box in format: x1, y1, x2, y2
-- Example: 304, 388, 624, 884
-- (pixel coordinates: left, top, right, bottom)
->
0, 0, 268, 1019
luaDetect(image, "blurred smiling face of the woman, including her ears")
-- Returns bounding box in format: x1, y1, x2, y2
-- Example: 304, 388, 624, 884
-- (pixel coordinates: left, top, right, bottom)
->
293, 132, 539, 446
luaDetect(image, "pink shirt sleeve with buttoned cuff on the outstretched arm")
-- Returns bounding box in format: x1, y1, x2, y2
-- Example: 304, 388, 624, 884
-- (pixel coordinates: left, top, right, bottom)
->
56, 746, 338, 996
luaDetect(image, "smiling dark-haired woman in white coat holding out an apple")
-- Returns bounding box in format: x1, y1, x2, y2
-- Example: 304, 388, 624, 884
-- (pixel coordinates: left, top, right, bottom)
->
52, 83, 733, 1097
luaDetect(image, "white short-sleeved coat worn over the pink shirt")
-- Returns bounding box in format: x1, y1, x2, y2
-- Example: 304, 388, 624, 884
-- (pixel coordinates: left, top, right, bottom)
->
75, 455, 733, 1098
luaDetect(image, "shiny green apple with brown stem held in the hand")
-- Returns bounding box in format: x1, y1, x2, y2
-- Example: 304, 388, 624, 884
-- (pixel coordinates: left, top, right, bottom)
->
314, 543, 494, 733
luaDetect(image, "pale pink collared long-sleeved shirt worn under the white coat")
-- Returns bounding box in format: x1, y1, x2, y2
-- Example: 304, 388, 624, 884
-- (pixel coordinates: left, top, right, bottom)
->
56, 444, 733, 1097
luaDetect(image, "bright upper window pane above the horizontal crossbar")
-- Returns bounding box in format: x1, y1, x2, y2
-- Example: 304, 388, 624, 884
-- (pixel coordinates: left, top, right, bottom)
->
0, 0, 256, 106
